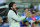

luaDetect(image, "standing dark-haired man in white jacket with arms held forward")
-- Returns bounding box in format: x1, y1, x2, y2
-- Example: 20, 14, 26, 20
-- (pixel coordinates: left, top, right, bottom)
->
8, 2, 27, 27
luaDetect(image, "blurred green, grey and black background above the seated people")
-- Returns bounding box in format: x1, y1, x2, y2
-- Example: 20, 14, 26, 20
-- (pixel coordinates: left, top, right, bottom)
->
0, 0, 40, 16
